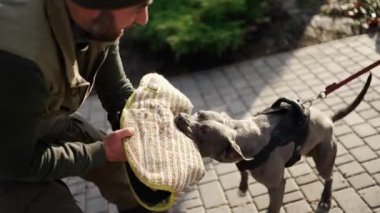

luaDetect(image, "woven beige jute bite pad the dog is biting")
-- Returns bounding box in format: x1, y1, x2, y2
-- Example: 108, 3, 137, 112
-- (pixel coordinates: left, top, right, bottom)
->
121, 73, 205, 210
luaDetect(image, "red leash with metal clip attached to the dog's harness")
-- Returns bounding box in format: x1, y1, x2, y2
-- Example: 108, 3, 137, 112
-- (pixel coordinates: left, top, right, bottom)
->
303, 60, 380, 106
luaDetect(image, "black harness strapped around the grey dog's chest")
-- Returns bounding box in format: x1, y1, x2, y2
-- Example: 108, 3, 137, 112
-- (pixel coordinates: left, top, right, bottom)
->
236, 98, 309, 171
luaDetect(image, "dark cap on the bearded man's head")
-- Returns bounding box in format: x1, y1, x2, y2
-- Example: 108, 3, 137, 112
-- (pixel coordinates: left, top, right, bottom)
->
71, 0, 149, 10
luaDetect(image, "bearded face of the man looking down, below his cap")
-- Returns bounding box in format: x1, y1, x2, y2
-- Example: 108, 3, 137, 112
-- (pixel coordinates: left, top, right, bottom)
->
81, 1, 150, 42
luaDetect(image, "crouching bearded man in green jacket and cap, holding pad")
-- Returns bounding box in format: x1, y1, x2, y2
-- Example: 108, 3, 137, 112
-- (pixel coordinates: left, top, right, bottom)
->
0, 0, 157, 213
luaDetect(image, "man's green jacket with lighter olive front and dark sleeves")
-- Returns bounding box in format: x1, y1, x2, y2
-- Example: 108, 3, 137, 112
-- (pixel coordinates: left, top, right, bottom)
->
0, 0, 133, 181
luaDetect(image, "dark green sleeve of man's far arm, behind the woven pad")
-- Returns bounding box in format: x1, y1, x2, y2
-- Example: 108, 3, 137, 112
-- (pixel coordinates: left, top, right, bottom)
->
95, 43, 134, 130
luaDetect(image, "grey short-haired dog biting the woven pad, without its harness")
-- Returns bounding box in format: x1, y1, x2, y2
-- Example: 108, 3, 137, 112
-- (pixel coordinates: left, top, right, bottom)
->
174, 74, 372, 213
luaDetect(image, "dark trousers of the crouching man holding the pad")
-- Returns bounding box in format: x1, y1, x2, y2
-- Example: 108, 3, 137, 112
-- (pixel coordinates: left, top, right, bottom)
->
0, 113, 138, 213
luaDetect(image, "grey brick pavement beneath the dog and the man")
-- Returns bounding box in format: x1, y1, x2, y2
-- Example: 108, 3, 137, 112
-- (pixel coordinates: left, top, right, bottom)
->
66, 35, 380, 213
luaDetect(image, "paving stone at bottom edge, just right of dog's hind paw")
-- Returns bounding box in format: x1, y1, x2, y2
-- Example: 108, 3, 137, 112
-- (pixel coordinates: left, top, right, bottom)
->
333, 188, 371, 213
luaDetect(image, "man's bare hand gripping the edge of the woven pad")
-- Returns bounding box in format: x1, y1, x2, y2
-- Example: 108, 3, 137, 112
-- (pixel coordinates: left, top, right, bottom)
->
103, 128, 134, 162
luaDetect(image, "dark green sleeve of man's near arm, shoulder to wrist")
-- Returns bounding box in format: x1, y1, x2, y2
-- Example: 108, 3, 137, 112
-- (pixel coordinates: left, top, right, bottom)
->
0, 51, 105, 181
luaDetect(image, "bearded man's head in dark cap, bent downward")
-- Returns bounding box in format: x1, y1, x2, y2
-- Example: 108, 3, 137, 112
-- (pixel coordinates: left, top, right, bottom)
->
66, 0, 152, 41
